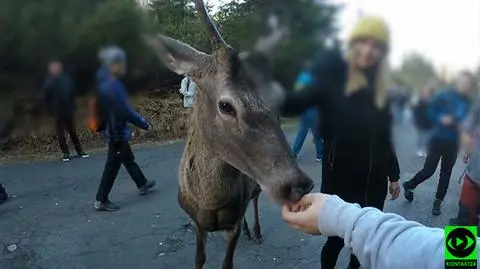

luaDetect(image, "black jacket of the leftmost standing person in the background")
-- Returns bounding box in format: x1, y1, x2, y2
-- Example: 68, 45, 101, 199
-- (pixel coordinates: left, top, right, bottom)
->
44, 74, 75, 117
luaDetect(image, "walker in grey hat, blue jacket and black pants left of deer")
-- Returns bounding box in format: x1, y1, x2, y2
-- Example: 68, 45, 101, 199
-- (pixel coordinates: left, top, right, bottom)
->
95, 47, 155, 211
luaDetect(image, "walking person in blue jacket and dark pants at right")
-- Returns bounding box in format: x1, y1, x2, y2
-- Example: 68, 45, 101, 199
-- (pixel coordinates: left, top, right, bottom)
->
403, 71, 474, 215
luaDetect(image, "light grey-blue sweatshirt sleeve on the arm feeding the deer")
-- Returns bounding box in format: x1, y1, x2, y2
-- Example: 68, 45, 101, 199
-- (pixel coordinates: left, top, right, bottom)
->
318, 196, 480, 269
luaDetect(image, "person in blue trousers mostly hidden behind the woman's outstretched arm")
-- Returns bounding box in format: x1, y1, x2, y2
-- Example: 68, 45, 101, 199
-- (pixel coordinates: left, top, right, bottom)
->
292, 68, 323, 162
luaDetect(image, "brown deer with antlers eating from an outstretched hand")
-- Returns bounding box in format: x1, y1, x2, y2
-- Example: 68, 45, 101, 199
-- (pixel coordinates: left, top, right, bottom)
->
144, 0, 314, 269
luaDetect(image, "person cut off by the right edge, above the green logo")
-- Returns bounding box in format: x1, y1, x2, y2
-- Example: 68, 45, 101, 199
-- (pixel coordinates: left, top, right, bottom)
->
450, 100, 480, 226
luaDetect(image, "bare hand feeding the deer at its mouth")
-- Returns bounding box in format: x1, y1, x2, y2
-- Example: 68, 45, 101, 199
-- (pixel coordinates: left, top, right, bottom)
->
282, 193, 329, 235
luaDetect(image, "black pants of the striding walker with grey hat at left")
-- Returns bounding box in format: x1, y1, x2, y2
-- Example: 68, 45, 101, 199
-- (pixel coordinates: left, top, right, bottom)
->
97, 142, 147, 203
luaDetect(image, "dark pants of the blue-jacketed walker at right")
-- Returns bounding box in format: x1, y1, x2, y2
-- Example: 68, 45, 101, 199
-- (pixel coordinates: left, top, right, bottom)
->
405, 139, 458, 201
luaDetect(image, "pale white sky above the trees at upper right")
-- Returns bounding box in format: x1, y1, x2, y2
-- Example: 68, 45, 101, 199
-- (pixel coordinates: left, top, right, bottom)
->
208, 0, 480, 73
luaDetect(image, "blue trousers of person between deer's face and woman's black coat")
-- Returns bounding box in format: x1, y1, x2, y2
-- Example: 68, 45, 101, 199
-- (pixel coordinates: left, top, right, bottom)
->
292, 108, 323, 159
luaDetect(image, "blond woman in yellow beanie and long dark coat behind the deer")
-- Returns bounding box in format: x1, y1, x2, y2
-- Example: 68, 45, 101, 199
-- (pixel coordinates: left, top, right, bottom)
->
283, 16, 400, 269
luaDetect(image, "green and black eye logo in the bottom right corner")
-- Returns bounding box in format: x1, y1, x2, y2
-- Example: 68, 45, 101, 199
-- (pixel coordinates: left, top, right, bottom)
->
445, 226, 478, 269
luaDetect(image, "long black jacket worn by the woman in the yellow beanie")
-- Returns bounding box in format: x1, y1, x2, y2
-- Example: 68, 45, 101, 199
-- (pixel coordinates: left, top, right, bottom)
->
283, 50, 400, 208
